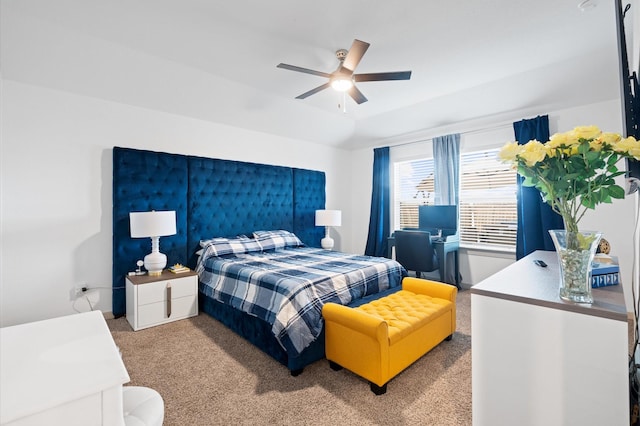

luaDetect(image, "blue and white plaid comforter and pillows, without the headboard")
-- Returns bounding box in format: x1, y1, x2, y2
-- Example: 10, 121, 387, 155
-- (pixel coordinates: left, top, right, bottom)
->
196, 230, 406, 374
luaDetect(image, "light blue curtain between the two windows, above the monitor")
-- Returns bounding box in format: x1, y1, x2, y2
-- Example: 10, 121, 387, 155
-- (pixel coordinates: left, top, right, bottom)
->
433, 133, 460, 205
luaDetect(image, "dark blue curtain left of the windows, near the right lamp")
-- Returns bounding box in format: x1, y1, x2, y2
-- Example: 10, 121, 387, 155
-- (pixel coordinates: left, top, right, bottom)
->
364, 147, 391, 257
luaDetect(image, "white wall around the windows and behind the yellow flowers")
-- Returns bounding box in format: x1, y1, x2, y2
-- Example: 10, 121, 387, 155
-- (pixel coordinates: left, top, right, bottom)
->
351, 100, 635, 311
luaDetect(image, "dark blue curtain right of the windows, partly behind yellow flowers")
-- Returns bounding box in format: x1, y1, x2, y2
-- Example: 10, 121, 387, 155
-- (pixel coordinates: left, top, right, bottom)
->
513, 115, 564, 259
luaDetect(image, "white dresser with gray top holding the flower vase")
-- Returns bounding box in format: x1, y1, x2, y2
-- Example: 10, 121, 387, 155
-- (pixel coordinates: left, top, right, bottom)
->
471, 251, 630, 426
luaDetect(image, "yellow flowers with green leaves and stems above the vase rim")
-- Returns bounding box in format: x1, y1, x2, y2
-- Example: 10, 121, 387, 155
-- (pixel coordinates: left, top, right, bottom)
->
499, 126, 640, 232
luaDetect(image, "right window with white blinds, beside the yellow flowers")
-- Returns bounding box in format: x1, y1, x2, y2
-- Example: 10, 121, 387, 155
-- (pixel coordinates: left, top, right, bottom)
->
460, 149, 517, 249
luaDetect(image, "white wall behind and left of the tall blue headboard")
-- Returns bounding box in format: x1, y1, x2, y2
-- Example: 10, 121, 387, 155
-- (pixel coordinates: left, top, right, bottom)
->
0, 80, 351, 326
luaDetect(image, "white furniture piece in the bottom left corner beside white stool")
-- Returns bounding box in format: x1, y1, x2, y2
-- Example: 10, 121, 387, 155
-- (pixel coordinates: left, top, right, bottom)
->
0, 311, 129, 426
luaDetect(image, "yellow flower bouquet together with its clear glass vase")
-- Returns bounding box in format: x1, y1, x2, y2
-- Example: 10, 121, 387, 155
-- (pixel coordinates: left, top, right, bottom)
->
499, 126, 640, 303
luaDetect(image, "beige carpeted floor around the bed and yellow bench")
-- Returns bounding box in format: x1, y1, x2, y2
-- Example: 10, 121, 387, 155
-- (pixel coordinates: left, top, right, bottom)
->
107, 290, 471, 426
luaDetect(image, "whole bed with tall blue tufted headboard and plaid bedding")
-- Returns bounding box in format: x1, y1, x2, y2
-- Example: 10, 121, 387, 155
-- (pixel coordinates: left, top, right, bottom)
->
113, 147, 406, 375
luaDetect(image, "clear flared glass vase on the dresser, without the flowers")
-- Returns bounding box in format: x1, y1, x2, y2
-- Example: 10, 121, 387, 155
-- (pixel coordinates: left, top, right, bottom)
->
549, 230, 602, 303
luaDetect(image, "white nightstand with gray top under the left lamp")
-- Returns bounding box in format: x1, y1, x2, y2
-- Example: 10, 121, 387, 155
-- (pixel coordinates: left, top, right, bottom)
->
126, 270, 198, 331
